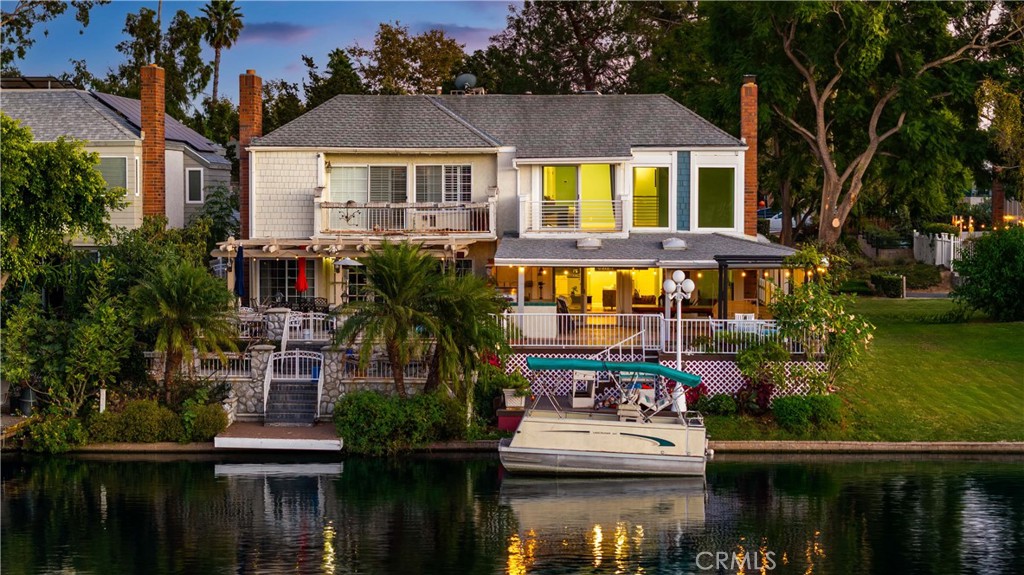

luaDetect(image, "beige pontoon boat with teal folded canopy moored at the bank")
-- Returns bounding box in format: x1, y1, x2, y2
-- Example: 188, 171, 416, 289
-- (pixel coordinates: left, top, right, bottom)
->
498, 357, 713, 476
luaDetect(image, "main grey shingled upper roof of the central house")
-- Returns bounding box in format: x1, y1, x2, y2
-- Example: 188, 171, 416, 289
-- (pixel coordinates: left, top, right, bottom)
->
253, 94, 743, 159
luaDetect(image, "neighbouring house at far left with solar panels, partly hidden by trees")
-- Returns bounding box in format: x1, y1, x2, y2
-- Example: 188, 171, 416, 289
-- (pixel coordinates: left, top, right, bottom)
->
0, 65, 231, 235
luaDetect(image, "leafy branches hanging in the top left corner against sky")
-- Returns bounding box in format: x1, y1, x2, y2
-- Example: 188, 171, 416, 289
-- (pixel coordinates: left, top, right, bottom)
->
0, 0, 110, 73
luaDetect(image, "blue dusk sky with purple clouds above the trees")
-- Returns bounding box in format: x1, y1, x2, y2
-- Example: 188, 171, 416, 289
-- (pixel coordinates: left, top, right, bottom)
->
12, 0, 509, 101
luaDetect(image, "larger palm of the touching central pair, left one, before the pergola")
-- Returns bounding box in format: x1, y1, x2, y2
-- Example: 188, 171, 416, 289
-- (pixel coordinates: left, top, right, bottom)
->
335, 241, 439, 397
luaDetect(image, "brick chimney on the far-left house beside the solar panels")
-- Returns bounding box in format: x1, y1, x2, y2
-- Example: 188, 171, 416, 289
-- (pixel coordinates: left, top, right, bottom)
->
141, 63, 167, 216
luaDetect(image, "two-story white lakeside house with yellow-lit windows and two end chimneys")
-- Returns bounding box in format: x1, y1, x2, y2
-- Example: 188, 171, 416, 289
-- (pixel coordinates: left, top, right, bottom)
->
228, 71, 802, 319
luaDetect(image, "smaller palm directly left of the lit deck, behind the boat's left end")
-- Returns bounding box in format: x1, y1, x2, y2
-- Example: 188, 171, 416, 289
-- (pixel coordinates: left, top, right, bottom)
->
425, 273, 508, 409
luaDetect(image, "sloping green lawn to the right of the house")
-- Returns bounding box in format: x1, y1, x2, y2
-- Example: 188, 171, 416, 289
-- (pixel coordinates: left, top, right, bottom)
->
708, 298, 1024, 441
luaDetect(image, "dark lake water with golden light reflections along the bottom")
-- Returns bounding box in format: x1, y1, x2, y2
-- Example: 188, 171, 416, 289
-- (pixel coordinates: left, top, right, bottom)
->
0, 455, 1024, 575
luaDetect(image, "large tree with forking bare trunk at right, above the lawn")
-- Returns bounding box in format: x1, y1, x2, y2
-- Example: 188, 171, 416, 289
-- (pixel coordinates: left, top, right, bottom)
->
706, 2, 1024, 244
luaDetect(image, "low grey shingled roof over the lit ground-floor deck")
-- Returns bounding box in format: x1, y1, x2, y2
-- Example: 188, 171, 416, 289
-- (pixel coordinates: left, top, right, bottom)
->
495, 232, 796, 269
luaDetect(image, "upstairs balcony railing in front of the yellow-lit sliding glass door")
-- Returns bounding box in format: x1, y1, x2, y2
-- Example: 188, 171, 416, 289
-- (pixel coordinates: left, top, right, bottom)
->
519, 200, 623, 232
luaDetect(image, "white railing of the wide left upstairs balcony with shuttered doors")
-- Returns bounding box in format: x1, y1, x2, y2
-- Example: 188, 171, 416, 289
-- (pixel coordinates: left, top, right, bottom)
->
314, 198, 497, 237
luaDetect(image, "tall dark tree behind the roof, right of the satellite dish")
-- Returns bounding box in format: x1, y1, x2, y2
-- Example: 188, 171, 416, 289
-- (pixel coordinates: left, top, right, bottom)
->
490, 1, 636, 94
